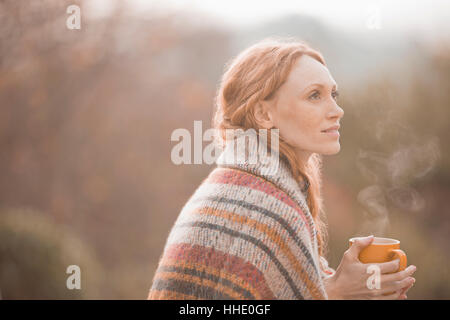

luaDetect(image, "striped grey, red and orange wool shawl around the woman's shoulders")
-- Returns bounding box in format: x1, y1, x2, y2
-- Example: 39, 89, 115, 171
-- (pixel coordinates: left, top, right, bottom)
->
148, 131, 334, 300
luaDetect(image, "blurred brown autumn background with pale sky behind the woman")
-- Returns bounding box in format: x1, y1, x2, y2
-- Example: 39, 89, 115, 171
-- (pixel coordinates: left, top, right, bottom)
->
0, 0, 450, 299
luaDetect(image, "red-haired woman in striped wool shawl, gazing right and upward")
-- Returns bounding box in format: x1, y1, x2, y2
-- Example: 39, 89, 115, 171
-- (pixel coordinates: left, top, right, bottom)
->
148, 39, 415, 299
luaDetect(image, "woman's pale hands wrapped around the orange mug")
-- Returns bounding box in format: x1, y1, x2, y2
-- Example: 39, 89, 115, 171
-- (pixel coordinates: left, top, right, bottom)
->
325, 236, 416, 300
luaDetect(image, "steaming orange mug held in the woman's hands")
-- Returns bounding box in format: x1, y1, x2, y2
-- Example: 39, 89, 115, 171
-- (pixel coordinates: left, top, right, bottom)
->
349, 237, 407, 295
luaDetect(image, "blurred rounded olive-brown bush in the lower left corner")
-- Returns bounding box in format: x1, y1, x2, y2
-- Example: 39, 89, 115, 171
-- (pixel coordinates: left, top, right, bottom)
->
0, 209, 103, 299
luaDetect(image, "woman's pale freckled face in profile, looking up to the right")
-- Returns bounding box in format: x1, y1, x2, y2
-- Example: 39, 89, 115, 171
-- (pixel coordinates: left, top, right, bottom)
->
271, 55, 344, 161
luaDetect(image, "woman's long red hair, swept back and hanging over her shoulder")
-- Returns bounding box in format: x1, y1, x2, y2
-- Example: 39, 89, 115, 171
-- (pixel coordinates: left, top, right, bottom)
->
213, 38, 326, 255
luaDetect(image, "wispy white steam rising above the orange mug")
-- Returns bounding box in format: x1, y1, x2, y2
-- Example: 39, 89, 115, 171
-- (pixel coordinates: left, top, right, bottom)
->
356, 120, 440, 236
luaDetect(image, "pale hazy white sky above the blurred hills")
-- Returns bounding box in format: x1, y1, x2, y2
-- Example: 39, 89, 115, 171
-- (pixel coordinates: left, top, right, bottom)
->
89, 0, 450, 33
